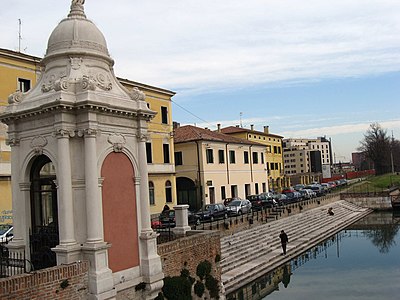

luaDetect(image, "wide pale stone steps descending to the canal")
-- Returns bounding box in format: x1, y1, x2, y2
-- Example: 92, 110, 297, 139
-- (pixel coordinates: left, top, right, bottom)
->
221, 200, 372, 294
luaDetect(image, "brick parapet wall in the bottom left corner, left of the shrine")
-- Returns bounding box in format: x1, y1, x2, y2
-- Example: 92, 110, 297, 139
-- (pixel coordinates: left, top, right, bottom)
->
0, 262, 88, 300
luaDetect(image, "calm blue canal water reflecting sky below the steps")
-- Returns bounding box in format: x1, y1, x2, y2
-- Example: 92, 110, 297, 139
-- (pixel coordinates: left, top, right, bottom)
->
227, 212, 400, 300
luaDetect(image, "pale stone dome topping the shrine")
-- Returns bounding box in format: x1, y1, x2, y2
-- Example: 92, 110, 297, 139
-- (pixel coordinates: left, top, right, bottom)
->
44, 1, 112, 62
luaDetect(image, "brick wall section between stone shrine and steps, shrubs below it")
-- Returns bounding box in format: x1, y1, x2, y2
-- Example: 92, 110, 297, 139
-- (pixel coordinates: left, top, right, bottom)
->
157, 231, 221, 281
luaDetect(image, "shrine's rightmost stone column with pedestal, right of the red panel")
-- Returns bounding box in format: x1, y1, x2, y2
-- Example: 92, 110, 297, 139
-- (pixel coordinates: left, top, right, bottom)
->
136, 134, 164, 299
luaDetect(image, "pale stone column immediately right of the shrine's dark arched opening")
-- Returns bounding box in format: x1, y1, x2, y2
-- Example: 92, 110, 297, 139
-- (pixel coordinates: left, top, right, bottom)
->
52, 129, 82, 264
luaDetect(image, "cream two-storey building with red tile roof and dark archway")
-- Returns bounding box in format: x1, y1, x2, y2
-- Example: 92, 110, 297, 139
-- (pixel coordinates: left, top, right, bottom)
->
174, 125, 268, 210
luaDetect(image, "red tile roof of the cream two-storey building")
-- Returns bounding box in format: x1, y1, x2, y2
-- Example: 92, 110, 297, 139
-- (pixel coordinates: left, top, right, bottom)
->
174, 125, 264, 146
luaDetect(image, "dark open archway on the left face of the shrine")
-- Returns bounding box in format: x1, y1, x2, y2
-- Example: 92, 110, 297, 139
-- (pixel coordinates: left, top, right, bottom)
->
29, 155, 59, 270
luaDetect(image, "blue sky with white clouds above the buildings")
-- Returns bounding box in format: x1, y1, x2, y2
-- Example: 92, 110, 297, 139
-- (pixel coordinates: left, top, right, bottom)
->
0, 0, 400, 162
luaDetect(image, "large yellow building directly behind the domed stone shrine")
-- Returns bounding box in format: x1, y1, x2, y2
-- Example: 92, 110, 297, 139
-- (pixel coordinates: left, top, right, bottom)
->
0, 48, 176, 219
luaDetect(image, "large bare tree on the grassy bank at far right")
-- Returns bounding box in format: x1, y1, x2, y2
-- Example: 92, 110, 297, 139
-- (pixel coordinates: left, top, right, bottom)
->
358, 123, 392, 175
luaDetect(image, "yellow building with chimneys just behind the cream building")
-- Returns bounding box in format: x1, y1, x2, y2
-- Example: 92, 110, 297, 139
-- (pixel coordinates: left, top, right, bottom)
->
218, 125, 290, 191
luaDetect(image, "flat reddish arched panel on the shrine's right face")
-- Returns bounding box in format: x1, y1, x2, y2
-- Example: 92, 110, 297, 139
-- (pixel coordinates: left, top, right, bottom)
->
101, 152, 138, 272
